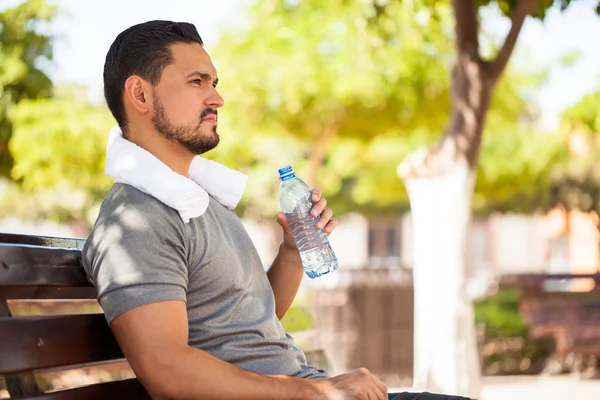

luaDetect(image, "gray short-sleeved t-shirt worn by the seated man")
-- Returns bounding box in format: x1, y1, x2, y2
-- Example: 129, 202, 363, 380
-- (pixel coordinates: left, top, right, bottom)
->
83, 184, 326, 379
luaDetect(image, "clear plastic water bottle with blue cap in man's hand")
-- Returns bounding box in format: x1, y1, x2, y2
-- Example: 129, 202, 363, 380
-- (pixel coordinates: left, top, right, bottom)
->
279, 166, 338, 278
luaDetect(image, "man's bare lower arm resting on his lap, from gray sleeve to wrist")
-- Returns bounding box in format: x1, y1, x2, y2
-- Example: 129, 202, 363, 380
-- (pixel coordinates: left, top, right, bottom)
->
111, 301, 332, 400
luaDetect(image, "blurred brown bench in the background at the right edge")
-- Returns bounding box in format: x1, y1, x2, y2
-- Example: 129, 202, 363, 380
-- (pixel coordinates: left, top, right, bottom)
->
509, 274, 600, 359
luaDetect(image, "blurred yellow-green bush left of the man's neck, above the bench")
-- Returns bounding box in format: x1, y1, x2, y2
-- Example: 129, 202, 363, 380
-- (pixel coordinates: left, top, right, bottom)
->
10, 88, 115, 192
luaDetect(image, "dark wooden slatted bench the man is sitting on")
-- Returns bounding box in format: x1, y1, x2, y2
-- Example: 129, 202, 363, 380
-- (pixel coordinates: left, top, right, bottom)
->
0, 233, 149, 400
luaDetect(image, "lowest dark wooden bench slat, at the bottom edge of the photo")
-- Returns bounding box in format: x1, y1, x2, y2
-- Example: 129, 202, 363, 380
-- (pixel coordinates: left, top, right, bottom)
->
23, 379, 150, 400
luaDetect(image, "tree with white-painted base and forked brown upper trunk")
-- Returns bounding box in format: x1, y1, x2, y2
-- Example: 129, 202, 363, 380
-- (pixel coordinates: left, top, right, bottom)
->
398, 0, 600, 397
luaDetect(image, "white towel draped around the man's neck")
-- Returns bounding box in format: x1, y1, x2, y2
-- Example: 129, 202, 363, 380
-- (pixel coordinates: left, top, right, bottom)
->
105, 126, 248, 223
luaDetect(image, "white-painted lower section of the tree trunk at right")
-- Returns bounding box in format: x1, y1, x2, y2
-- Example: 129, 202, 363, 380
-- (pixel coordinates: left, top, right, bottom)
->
406, 165, 480, 398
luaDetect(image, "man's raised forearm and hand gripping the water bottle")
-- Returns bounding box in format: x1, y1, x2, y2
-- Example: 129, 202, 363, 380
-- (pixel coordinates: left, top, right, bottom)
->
267, 190, 338, 319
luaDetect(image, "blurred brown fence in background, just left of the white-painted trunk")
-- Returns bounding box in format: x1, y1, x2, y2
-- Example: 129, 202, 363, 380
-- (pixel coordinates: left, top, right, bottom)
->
307, 269, 414, 385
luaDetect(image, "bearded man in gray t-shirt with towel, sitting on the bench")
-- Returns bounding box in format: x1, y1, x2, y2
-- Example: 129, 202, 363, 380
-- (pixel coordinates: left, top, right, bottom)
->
83, 21, 468, 400
